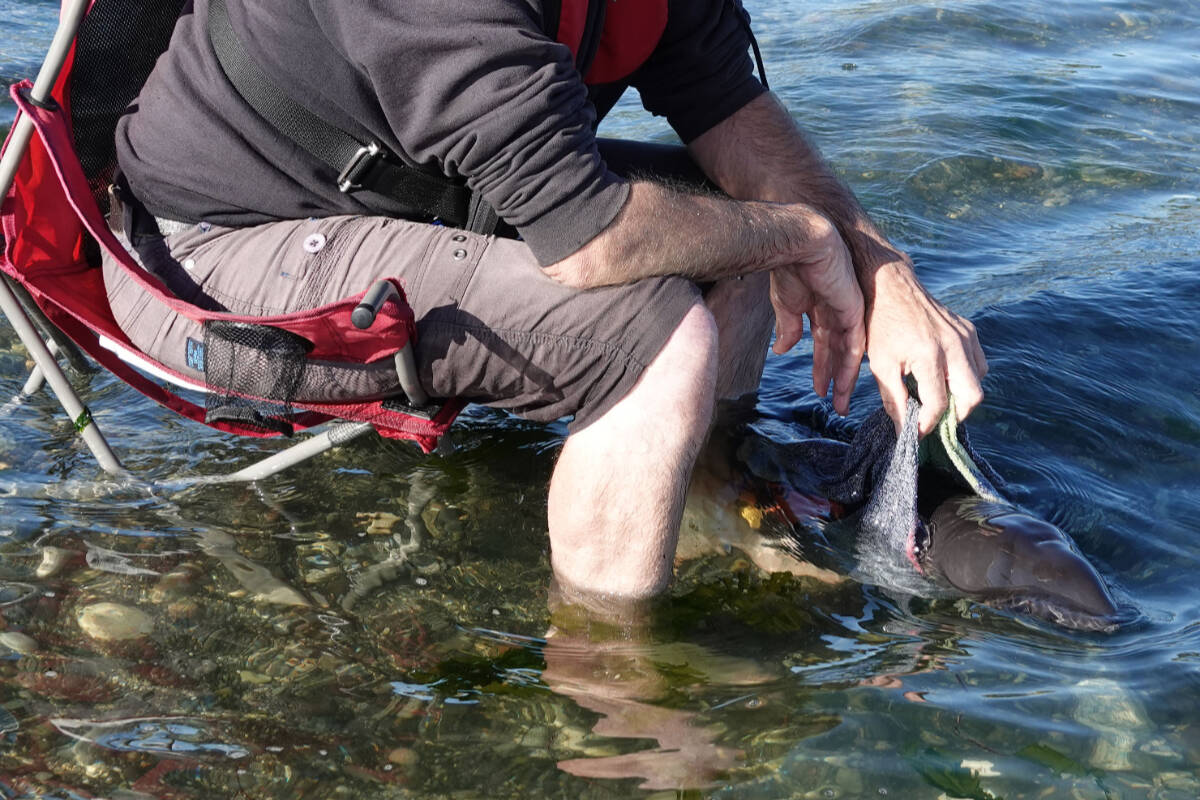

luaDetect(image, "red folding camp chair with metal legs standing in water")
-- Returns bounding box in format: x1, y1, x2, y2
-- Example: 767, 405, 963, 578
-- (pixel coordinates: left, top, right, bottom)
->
0, 0, 463, 480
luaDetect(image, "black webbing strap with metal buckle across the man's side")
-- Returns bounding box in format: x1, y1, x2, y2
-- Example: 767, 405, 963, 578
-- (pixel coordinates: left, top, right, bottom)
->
208, 0, 499, 234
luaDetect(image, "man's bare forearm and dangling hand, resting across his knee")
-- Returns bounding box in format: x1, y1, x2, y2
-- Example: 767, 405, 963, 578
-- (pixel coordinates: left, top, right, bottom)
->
546, 151, 866, 413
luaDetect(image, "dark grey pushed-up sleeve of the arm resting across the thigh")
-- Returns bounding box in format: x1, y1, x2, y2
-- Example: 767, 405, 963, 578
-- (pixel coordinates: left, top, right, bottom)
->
325, 0, 629, 265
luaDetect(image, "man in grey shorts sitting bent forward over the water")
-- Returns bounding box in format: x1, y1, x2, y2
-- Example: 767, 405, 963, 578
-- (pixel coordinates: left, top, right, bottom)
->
106, 0, 986, 597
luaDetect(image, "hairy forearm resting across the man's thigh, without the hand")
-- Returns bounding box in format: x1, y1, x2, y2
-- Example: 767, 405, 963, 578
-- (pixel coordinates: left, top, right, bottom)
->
546, 181, 841, 288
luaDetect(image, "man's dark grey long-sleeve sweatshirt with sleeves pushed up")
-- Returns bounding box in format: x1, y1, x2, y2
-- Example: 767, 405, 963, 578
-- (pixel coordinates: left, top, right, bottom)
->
116, 0, 763, 264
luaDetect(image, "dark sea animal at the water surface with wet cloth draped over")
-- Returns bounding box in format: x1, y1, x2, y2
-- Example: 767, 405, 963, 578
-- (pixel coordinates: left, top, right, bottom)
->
809, 398, 1123, 631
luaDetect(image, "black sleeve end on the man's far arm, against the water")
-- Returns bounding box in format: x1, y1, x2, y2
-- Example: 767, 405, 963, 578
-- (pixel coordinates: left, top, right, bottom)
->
631, 0, 766, 143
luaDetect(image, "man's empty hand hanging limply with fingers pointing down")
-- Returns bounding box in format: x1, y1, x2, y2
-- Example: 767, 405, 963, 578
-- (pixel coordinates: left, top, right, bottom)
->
770, 215, 866, 414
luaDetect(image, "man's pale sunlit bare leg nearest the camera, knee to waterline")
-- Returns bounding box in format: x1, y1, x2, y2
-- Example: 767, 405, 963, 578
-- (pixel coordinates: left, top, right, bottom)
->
548, 302, 718, 597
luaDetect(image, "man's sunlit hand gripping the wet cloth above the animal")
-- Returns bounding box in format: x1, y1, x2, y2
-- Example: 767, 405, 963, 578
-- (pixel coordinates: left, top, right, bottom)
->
859, 251, 988, 435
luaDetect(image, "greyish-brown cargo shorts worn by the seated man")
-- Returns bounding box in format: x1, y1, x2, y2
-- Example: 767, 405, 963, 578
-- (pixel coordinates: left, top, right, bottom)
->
103, 216, 701, 431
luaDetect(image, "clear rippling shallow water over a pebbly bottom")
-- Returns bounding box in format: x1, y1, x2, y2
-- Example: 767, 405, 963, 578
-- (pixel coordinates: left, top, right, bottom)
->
0, 0, 1200, 800
